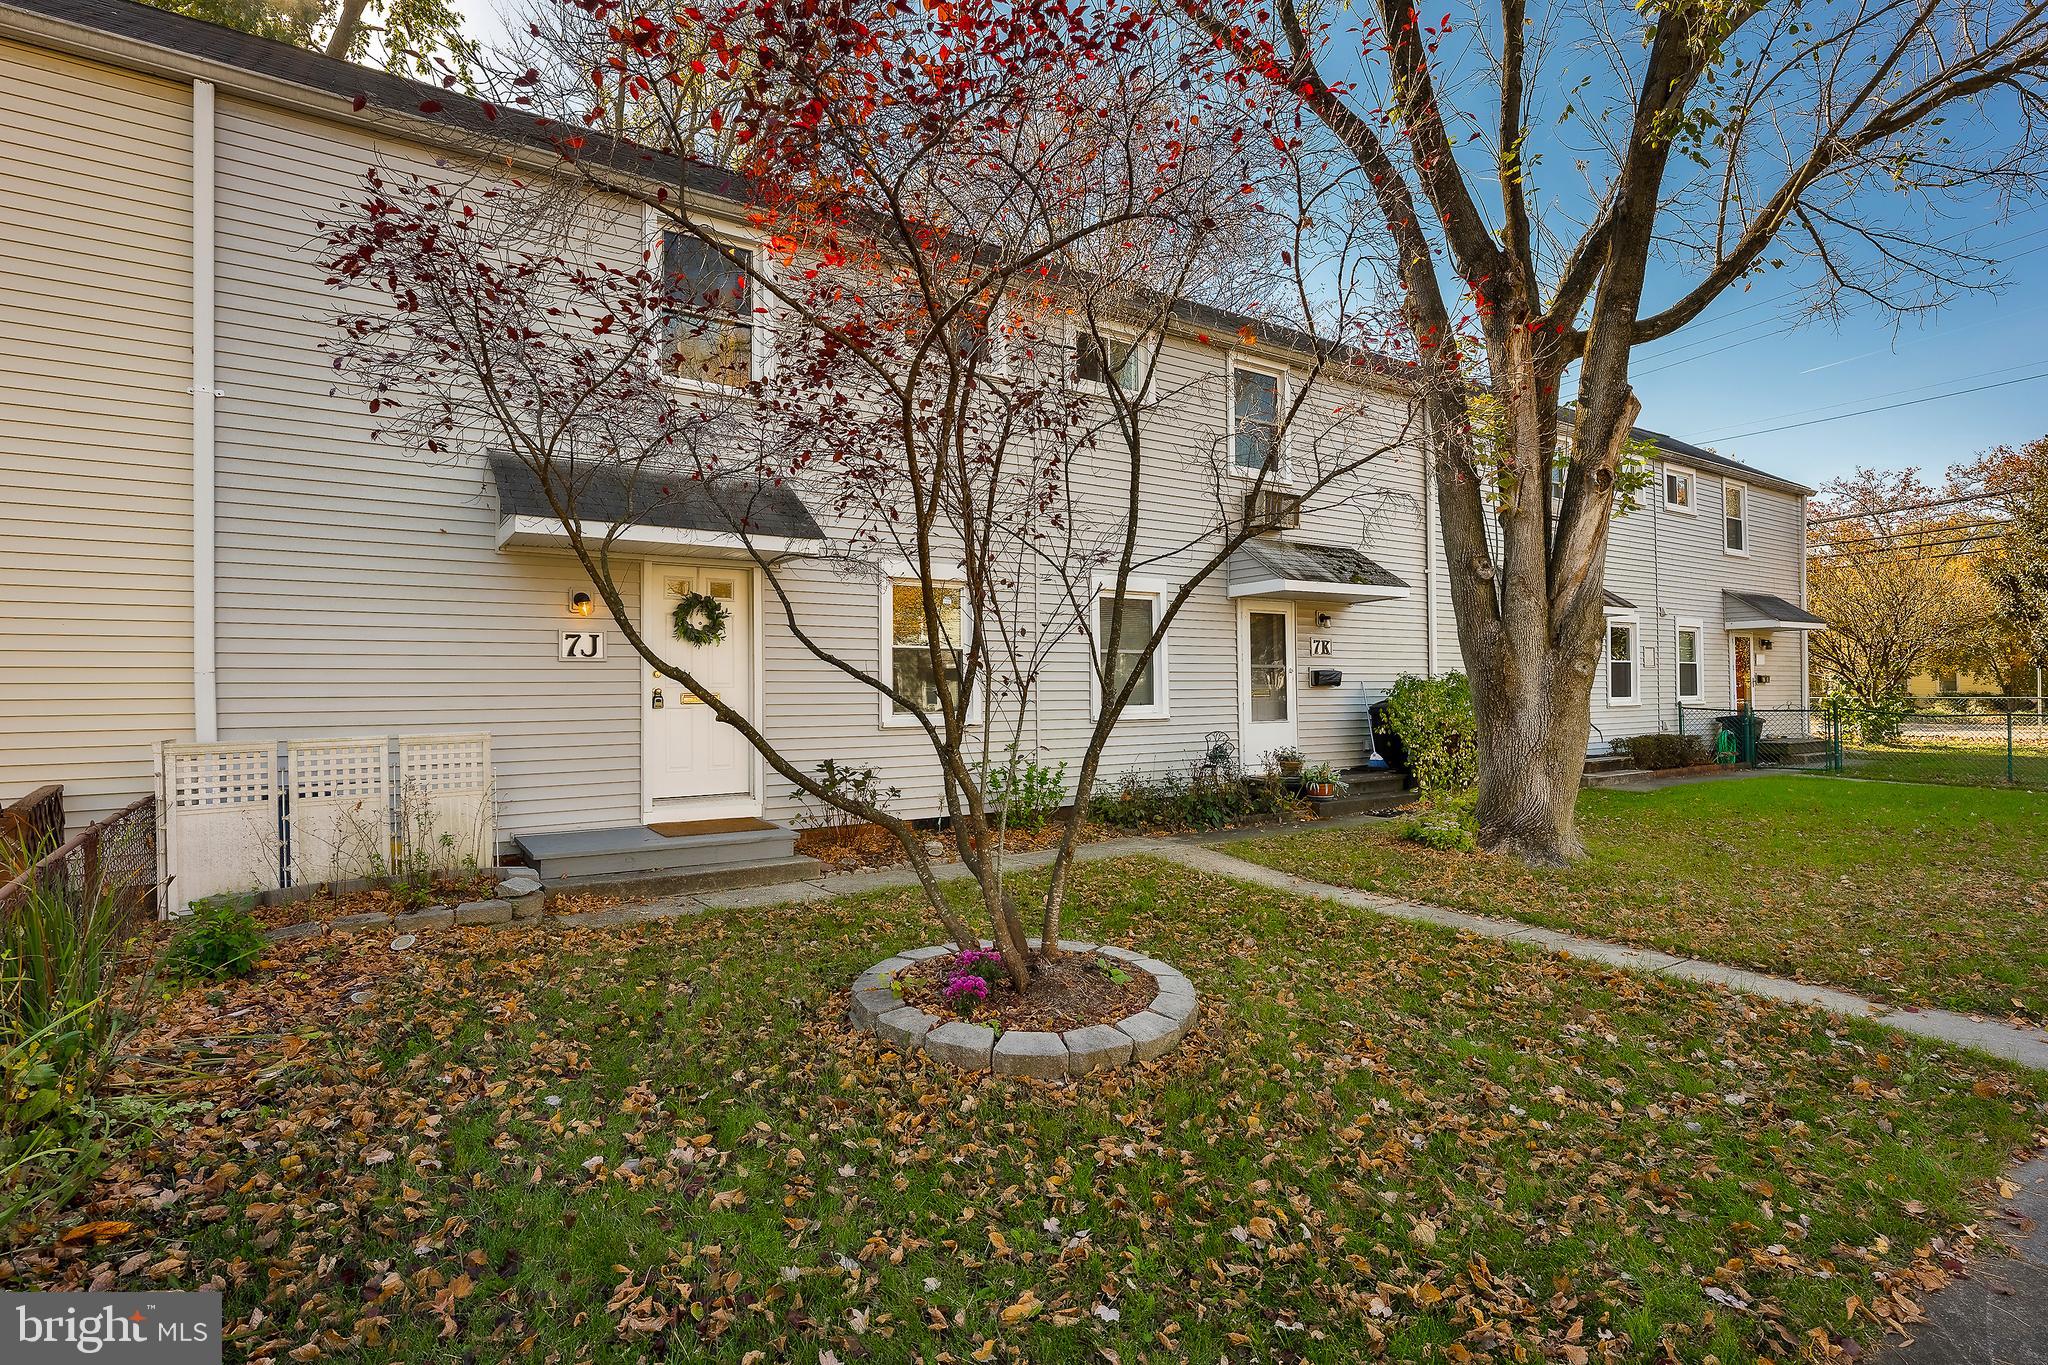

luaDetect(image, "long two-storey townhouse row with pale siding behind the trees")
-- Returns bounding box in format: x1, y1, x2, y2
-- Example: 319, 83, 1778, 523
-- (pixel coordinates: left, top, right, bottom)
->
0, 0, 1815, 855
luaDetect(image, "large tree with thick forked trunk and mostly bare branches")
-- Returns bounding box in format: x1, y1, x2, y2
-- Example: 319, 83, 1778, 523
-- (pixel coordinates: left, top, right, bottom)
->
1163, 0, 2048, 862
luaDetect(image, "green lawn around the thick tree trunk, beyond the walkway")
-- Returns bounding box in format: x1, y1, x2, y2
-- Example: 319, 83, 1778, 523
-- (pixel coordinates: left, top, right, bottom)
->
1231, 776, 2048, 1021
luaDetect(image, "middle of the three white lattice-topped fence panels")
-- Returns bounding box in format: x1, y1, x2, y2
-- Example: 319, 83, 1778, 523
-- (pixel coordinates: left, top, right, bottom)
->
285, 737, 391, 886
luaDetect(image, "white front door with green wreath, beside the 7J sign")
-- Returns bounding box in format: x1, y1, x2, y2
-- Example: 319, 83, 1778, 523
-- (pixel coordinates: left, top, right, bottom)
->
641, 563, 760, 821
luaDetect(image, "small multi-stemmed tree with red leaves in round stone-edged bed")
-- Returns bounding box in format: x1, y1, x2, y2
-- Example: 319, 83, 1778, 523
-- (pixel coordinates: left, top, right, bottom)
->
324, 0, 1411, 986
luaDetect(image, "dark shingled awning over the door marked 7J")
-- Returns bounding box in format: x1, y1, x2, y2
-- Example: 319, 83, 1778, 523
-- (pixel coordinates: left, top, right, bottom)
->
489, 452, 825, 553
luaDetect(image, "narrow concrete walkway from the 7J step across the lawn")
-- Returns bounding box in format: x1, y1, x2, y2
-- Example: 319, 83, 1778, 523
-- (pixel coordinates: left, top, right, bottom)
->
557, 814, 2048, 1072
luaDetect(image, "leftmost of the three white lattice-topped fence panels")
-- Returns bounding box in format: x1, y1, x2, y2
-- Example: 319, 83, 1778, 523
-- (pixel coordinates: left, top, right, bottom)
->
158, 741, 281, 915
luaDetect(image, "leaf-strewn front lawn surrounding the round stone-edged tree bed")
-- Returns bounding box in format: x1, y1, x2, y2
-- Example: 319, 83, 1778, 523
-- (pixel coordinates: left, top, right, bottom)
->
6, 860, 2048, 1365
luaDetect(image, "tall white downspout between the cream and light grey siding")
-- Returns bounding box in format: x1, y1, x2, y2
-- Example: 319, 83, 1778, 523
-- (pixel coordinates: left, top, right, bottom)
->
193, 80, 221, 745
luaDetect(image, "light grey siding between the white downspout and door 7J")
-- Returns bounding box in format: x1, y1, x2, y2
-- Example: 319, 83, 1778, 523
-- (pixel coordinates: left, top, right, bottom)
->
215, 98, 643, 833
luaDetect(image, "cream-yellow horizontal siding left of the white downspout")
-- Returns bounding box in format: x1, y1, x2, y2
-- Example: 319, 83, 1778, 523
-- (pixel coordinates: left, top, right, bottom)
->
0, 41, 193, 825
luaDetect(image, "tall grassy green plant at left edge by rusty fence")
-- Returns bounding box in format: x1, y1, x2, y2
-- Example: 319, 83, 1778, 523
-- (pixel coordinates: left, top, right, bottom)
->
0, 878, 150, 1232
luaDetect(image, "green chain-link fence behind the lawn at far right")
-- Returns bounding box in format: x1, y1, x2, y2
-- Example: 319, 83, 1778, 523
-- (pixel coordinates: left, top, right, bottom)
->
1677, 698, 2048, 788
